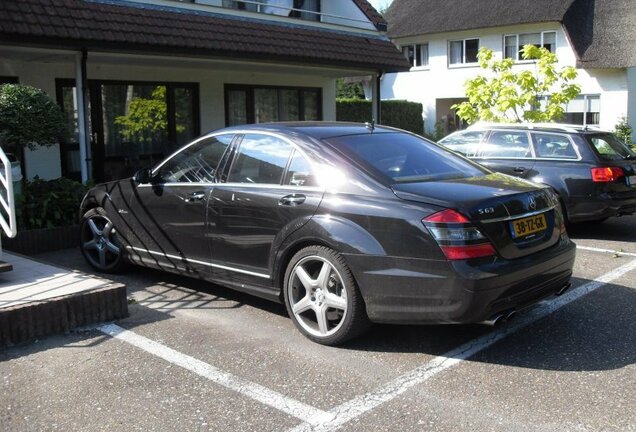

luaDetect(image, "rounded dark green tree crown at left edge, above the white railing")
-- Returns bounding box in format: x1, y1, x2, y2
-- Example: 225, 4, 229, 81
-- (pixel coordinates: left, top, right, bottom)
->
0, 84, 66, 156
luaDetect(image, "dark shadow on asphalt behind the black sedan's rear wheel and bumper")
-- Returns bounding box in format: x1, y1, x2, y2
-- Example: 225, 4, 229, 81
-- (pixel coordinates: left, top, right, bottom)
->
344, 279, 636, 371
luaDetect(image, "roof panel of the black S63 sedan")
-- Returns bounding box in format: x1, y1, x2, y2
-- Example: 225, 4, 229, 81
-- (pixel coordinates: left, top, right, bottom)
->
214, 122, 402, 139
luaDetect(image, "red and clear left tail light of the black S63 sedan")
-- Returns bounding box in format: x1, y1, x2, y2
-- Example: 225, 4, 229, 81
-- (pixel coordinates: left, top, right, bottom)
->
422, 209, 495, 260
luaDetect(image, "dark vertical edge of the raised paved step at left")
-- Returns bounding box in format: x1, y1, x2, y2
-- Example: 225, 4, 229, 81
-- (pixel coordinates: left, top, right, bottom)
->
0, 283, 128, 349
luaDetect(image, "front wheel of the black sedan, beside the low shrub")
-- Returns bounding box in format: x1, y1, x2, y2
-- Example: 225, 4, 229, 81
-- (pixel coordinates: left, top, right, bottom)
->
80, 207, 126, 273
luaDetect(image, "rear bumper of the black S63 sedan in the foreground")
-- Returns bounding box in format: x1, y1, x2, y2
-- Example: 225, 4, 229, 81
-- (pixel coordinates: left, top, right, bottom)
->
345, 237, 576, 324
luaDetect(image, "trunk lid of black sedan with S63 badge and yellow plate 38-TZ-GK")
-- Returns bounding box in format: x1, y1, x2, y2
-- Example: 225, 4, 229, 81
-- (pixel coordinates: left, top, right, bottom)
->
392, 173, 562, 259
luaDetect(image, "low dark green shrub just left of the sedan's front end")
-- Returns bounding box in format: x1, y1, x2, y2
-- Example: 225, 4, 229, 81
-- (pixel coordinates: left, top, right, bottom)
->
16, 177, 88, 230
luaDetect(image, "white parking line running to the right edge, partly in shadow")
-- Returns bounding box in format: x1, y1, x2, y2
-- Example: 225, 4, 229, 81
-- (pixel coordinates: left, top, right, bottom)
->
290, 260, 636, 432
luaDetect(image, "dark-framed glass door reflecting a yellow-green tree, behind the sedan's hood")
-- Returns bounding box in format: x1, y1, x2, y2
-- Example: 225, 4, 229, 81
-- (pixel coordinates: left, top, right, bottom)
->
58, 80, 199, 182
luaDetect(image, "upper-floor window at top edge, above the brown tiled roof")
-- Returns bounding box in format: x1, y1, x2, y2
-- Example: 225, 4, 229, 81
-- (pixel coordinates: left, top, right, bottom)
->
223, 0, 320, 21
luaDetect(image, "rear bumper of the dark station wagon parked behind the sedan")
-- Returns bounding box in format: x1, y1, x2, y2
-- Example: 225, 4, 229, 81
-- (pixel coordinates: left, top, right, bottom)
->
568, 190, 636, 222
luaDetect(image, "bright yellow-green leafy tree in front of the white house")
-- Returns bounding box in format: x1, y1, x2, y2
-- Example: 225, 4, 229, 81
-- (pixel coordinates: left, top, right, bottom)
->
451, 45, 581, 123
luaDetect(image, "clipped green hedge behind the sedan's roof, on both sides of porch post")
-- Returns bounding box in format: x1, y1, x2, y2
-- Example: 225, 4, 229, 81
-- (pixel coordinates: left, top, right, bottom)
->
336, 99, 424, 135
